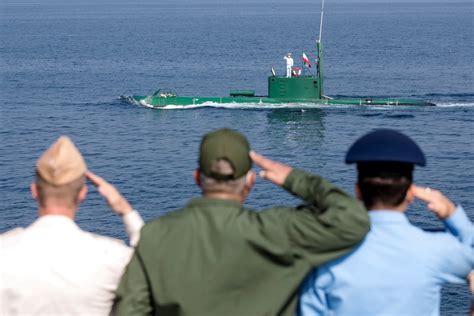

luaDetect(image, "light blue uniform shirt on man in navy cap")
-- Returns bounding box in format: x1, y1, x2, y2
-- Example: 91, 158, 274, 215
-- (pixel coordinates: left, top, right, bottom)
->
298, 206, 474, 316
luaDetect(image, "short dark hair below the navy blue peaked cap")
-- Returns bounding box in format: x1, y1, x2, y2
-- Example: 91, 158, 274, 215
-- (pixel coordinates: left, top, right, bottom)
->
358, 163, 413, 210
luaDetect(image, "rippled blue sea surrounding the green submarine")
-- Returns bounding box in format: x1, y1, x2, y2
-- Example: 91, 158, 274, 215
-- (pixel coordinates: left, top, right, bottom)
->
0, 1, 474, 315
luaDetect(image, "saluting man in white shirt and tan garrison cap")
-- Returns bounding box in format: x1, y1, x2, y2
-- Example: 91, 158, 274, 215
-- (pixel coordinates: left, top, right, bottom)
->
0, 136, 143, 315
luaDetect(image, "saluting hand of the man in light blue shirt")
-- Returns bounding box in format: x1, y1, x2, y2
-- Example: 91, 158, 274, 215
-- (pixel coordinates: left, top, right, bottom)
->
413, 185, 456, 219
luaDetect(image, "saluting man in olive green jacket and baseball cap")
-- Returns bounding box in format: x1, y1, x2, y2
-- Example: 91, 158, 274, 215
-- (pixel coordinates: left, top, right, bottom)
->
115, 129, 369, 316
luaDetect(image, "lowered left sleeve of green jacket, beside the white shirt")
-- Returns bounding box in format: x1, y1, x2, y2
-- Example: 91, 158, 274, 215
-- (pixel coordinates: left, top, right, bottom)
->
112, 239, 154, 316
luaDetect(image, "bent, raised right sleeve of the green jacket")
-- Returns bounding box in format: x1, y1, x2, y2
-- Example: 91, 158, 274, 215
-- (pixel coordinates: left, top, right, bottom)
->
283, 170, 369, 266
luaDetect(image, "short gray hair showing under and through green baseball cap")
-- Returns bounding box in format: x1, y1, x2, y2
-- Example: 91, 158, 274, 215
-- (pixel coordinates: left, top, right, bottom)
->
200, 159, 246, 194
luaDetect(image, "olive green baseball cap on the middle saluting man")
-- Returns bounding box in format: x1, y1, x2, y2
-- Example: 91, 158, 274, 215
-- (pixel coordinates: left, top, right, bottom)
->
199, 128, 252, 180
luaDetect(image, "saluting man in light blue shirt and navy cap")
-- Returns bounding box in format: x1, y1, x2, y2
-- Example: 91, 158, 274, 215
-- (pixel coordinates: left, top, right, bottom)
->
299, 129, 474, 316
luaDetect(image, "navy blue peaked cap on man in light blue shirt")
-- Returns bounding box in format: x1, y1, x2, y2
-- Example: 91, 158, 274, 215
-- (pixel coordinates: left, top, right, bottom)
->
346, 128, 426, 166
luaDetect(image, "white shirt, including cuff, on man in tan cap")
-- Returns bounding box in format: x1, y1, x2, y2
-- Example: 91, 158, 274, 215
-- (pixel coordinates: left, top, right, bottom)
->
0, 211, 143, 315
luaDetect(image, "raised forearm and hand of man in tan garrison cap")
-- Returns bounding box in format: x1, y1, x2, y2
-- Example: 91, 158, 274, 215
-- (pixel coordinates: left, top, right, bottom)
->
86, 171, 144, 247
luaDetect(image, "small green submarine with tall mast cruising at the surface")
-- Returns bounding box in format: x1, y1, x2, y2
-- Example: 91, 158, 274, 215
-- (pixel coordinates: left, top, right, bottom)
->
121, 0, 435, 108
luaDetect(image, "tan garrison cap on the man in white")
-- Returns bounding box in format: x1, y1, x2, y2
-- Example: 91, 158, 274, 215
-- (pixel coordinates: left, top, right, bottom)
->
36, 136, 87, 185
